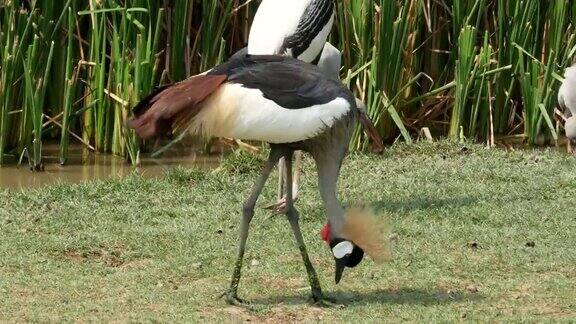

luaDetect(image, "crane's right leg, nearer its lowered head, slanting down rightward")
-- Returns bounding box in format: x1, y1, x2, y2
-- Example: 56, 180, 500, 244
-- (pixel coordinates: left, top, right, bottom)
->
286, 154, 324, 303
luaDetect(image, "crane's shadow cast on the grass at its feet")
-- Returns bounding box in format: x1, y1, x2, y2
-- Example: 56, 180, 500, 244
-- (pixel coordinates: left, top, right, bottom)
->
252, 288, 484, 306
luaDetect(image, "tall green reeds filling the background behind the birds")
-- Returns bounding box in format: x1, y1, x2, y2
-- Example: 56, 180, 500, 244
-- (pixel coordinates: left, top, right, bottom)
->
0, 0, 576, 168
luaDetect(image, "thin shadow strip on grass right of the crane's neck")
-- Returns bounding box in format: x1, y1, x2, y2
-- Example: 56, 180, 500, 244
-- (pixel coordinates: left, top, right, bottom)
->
372, 196, 478, 213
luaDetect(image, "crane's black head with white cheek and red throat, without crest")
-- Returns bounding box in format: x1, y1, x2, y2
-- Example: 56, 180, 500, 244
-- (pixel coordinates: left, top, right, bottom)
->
322, 224, 364, 283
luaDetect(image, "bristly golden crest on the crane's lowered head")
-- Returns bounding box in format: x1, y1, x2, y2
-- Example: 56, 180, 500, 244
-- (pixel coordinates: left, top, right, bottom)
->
342, 207, 392, 263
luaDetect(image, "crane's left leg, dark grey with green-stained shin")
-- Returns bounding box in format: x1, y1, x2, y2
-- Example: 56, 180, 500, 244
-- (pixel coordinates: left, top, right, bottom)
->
225, 148, 281, 305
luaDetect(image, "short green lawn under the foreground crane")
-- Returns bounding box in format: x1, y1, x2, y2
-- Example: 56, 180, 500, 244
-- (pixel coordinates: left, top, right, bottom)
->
0, 142, 576, 322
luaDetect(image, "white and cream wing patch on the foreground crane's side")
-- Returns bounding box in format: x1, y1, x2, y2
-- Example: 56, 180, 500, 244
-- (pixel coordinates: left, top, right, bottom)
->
193, 84, 350, 144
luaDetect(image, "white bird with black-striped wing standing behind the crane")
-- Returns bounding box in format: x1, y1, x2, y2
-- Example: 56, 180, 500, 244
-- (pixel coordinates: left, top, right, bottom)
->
247, 0, 383, 211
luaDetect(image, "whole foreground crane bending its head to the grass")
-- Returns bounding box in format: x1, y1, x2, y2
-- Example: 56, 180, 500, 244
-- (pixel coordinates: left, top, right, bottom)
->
130, 55, 382, 304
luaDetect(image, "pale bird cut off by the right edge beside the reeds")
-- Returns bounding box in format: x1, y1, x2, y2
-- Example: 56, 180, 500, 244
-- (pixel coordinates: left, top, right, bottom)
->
558, 66, 576, 153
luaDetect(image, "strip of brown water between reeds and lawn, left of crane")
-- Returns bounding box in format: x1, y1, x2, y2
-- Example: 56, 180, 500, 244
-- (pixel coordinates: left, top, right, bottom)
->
0, 145, 223, 190
